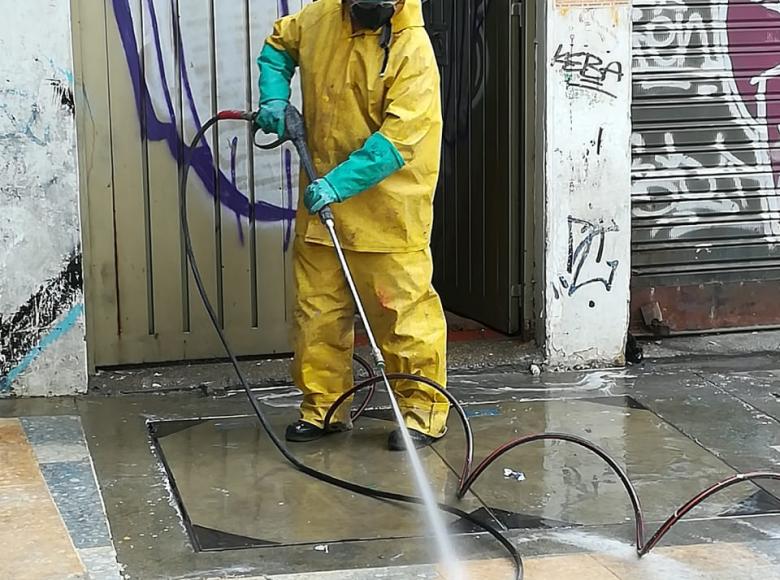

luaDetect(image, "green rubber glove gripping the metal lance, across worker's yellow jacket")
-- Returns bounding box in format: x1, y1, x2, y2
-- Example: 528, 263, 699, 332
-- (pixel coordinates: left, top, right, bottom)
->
303, 133, 404, 213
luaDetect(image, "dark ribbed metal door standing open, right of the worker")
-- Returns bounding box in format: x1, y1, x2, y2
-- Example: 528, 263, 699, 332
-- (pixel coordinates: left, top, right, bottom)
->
425, 0, 524, 333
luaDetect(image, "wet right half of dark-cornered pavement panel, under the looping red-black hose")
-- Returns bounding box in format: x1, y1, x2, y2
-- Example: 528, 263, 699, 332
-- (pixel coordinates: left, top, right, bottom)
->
435, 397, 780, 525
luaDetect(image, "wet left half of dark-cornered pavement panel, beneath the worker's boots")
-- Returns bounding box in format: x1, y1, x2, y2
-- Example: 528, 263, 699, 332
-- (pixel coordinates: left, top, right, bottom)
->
154, 415, 488, 551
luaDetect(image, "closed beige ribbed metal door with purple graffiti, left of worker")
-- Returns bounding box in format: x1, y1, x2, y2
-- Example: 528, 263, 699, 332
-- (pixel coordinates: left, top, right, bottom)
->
76, 0, 301, 366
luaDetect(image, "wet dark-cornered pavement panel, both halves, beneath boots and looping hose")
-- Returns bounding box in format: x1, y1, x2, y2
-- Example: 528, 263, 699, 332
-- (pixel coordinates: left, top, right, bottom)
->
148, 397, 780, 550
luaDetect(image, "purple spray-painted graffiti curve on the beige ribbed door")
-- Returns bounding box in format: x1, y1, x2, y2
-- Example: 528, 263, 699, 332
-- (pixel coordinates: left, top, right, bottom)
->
112, 0, 295, 250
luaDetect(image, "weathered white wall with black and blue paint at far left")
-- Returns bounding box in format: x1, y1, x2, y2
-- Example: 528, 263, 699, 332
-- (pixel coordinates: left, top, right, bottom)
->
0, 0, 86, 396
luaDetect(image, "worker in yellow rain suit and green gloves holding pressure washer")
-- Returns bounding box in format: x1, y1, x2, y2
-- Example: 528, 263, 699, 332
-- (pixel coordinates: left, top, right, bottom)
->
256, 0, 449, 450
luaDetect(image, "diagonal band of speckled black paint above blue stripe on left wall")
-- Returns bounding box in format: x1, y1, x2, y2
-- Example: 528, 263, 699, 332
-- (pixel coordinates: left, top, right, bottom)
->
0, 252, 83, 377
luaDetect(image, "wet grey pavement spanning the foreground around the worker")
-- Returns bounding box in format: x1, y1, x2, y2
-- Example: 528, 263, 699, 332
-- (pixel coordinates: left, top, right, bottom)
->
0, 355, 780, 580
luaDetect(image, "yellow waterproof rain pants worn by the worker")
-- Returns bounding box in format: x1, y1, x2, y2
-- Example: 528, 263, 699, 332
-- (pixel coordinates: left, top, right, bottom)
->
293, 238, 449, 437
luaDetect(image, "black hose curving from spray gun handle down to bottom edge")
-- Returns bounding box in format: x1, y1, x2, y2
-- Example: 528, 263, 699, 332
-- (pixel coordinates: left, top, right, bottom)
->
179, 107, 523, 580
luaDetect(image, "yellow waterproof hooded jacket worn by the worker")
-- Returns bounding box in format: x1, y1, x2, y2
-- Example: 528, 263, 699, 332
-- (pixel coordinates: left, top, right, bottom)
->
267, 0, 442, 252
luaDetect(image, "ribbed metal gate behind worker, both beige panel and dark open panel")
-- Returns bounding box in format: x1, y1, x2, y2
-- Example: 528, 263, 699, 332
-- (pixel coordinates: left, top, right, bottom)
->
74, 0, 523, 367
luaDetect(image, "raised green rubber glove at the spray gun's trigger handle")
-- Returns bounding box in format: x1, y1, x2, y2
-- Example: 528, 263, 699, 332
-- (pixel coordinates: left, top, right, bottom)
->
255, 43, 295, 137
